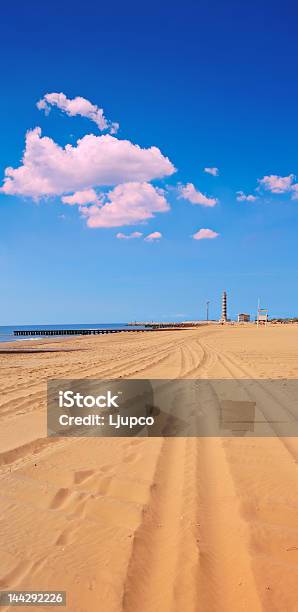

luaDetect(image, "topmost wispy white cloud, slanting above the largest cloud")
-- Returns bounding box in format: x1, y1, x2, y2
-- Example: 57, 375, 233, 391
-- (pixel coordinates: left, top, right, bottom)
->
37, 93, 119, 134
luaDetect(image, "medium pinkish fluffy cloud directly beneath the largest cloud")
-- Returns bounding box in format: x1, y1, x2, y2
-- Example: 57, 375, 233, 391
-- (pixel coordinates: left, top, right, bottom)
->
80, 182, 170, 227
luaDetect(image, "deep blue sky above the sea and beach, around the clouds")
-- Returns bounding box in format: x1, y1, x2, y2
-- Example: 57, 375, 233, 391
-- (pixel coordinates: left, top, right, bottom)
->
0, 1, 298, 325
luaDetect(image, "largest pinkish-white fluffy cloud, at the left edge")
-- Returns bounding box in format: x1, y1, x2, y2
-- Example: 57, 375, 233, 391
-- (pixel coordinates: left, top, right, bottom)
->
1, 127, 175, 199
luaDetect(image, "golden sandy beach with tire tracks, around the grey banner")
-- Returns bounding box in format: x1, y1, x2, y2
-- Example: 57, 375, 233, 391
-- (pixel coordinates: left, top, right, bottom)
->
0, 325, 298, 612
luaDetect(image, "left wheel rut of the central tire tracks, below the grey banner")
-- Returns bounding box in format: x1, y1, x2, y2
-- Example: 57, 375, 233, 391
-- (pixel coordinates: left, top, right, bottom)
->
122, 438, 197, 612
